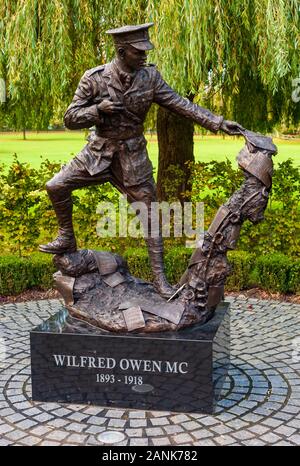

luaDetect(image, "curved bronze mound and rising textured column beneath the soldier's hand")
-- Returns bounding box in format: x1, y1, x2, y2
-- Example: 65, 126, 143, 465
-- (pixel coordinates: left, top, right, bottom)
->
54, 130, 277, 333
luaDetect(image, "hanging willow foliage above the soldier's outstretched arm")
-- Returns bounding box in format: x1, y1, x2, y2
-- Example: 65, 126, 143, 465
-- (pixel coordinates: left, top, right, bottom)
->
152, 0, 300, 131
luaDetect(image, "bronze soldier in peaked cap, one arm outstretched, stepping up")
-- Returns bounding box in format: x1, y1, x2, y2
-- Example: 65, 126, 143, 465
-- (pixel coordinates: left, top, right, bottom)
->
39, 23, 242, 297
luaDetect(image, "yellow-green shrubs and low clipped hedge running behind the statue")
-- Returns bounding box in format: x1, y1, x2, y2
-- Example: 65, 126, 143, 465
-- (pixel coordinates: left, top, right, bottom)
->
0, 158, 300, 294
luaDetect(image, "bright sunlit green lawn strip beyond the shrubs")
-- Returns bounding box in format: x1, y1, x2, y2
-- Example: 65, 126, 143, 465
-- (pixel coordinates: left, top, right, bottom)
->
0, 131, 300, 168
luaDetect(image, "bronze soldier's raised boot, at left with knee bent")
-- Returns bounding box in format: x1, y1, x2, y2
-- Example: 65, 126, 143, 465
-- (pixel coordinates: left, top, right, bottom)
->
39, 197, 77, 254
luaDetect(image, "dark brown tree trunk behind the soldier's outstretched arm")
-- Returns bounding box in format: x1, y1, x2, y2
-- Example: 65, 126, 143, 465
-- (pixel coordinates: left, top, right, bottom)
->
157, 107, 194, 202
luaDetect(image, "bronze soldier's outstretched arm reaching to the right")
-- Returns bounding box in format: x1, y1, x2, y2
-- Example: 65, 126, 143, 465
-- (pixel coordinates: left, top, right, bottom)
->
153, 71, 243, 135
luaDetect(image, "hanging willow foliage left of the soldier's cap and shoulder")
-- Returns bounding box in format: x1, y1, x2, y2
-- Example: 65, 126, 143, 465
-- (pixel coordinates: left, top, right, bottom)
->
0, 0, 103, 129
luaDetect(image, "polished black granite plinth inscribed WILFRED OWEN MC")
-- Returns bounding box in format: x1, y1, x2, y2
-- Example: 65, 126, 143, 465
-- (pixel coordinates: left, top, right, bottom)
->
30, 303, 230, 413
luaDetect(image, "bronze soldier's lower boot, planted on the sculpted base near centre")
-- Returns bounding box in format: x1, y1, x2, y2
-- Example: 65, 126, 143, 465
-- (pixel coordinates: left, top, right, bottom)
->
146, 237, 176, 298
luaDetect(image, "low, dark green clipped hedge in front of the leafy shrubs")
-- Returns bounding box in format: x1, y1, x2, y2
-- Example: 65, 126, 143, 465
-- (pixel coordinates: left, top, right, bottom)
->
0, 247, 300, 296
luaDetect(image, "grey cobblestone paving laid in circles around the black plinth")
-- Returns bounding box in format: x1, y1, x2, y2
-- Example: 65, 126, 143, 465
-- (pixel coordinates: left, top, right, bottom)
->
0, 298, 300, 446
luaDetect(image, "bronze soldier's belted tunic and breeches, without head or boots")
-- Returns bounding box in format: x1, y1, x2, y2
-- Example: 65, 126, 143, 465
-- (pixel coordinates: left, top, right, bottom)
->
47, 61, 223, 212
